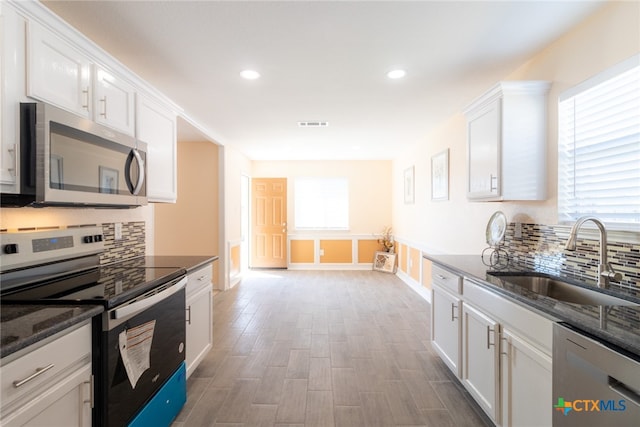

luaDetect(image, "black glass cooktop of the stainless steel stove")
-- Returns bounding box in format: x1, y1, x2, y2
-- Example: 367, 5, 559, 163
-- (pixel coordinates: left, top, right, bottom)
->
2, 259, 186, 308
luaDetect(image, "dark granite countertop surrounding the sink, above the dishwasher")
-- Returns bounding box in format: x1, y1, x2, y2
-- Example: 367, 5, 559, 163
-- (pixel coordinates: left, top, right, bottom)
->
424, 254, 640, 356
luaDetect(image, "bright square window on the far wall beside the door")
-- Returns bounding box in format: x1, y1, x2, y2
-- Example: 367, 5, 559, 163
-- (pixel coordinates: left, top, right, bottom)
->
293, 177, 349, 230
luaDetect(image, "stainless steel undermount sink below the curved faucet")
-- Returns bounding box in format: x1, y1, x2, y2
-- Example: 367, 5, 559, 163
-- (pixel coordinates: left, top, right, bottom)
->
489, 273, 640, 307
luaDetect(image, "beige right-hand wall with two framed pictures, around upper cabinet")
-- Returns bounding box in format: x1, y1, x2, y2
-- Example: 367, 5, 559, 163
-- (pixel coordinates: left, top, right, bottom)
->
392, 2, 640, 254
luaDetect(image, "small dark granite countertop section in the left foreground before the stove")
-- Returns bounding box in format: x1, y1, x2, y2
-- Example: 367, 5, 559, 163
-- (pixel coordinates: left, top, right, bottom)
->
0, 304, 104, 358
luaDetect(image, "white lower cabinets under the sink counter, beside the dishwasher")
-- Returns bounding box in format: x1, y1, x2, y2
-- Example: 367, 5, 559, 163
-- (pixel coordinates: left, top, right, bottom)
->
431, 264, 554, 427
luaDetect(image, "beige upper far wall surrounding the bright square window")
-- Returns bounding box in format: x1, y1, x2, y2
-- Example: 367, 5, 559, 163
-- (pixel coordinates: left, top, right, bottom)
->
252, 160, 391, 235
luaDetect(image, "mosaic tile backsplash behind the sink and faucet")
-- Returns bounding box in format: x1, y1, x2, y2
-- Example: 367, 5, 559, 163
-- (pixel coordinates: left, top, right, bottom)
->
505, 223, 640, 289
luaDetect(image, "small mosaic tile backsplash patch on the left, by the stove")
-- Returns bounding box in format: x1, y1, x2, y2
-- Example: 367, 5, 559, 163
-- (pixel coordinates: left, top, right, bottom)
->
100, 221, 146, 265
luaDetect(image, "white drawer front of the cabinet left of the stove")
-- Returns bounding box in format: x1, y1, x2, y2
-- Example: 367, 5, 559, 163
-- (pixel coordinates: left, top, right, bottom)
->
0, 323, 91, 413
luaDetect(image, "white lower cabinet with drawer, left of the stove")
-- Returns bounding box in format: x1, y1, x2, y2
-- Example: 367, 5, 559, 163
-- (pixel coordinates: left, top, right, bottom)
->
0, 323, 93, 427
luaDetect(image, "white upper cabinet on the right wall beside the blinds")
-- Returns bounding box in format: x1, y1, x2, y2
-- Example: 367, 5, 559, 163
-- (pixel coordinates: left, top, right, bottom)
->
464, 81, 551, 201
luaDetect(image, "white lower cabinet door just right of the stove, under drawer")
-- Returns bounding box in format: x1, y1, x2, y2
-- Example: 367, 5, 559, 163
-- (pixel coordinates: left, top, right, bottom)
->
185, 283, 213, 378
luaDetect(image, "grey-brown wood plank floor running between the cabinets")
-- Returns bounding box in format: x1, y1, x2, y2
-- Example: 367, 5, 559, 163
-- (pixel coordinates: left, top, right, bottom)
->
173, 270, 491, 427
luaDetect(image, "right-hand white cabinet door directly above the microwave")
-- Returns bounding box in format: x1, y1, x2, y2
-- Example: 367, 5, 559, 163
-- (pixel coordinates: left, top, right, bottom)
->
93, 66, 135, 135
